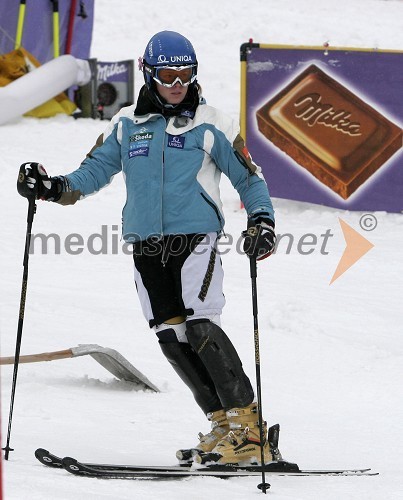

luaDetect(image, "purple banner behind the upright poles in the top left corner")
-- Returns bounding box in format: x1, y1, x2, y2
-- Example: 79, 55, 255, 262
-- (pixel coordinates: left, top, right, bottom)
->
0, 0, 94, 64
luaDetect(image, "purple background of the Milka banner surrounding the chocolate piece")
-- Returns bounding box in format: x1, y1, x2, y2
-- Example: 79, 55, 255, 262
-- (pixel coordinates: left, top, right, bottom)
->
246, 48, 403, 212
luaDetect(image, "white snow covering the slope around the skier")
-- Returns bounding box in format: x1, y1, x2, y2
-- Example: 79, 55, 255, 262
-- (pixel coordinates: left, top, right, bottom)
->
0, 0, 403, 500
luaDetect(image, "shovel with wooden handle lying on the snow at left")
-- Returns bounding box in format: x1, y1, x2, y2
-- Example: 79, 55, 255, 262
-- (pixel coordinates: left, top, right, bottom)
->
0, 344, 160, 392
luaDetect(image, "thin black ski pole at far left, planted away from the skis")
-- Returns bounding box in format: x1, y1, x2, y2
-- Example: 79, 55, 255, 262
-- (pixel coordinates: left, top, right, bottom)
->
3, 196, 36, 460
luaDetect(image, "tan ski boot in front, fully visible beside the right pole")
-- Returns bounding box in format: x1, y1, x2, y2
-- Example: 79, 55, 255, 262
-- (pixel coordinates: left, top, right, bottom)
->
193, 403, 281, 466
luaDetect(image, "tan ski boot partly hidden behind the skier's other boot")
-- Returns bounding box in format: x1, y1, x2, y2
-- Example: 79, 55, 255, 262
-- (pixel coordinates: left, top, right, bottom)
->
176, 410, 230, 465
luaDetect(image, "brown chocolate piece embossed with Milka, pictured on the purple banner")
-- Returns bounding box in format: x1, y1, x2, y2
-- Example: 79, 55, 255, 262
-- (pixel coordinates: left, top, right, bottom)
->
256, 64, 402, 200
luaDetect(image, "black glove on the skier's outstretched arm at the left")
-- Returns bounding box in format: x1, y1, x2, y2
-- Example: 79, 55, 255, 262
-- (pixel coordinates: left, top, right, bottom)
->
17, 162, 63, 201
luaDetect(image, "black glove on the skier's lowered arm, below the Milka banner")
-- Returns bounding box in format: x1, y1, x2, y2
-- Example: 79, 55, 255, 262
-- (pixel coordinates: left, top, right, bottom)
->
242, 216, 276, 260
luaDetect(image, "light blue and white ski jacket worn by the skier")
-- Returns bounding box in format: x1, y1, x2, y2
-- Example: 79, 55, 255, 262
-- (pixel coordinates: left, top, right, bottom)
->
60, 100, 274, 242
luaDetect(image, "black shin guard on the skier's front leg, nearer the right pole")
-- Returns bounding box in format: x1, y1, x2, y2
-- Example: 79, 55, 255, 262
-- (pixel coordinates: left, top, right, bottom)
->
186, 320, 254, 409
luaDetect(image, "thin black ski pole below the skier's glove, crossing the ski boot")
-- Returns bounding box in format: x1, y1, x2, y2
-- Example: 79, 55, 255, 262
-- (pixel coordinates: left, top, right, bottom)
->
249, 256, 270, 493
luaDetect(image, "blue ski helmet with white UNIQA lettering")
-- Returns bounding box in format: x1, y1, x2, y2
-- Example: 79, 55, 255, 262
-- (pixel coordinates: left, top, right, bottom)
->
142, 31, 197, 90
